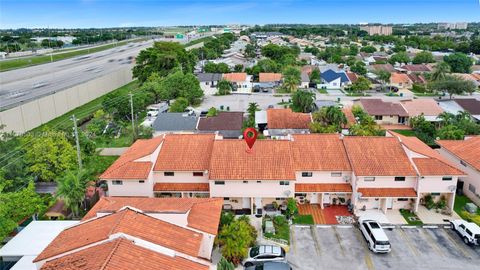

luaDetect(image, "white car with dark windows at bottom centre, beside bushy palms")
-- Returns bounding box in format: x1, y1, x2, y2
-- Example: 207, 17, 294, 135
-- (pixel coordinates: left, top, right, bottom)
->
243, 245, 286, 267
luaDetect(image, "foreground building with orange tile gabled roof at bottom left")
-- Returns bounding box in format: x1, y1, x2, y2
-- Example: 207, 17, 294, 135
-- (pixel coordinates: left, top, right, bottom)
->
33, 197, 222, 270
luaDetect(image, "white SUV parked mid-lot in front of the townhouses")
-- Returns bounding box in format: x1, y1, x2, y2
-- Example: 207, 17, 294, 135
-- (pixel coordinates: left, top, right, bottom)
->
359, 219, 391, 253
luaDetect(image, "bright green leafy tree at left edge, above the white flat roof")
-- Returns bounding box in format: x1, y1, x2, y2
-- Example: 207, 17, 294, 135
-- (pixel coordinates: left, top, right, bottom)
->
0, 181, 46, 241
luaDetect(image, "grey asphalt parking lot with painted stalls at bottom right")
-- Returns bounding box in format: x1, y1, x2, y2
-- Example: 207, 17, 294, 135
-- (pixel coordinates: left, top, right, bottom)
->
287, 226, 480, 270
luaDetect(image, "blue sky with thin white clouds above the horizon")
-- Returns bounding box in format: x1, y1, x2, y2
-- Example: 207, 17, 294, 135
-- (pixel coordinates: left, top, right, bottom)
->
0, 0, 480, 29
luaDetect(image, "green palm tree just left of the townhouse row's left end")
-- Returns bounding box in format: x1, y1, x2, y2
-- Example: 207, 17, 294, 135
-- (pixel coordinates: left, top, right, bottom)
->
56, 171, 87, 216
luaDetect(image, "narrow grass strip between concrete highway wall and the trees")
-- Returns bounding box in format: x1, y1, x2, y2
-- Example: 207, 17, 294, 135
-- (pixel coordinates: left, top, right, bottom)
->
34, 81, 138, 130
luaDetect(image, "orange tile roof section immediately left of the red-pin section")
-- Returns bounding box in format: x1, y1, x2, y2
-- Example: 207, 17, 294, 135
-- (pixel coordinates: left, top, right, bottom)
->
153, 134, 215, 171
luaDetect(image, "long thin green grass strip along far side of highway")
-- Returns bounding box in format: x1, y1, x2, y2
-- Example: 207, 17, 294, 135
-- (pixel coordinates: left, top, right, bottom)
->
0, 39, 145, 72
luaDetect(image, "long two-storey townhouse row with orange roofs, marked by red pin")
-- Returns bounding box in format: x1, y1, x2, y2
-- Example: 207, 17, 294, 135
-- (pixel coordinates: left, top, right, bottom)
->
100, 132, 465, 213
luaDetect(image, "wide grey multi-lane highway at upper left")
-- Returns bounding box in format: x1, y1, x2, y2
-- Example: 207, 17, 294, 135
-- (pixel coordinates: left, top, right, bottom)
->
0, 35, 204, 111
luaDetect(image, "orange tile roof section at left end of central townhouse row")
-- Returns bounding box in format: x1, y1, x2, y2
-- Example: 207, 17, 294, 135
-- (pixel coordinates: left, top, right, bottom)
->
100, 137, 163, 180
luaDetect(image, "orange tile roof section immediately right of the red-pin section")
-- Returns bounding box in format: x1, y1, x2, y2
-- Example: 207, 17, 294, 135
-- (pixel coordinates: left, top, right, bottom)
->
291, 134, 351, 171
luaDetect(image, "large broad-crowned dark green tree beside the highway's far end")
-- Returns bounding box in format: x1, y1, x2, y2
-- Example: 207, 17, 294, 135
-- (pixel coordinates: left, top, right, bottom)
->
133, 42, 196, 83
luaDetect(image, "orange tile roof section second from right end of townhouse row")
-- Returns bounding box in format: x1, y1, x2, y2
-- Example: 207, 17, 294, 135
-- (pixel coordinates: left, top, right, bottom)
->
343, 136, 417, 176
